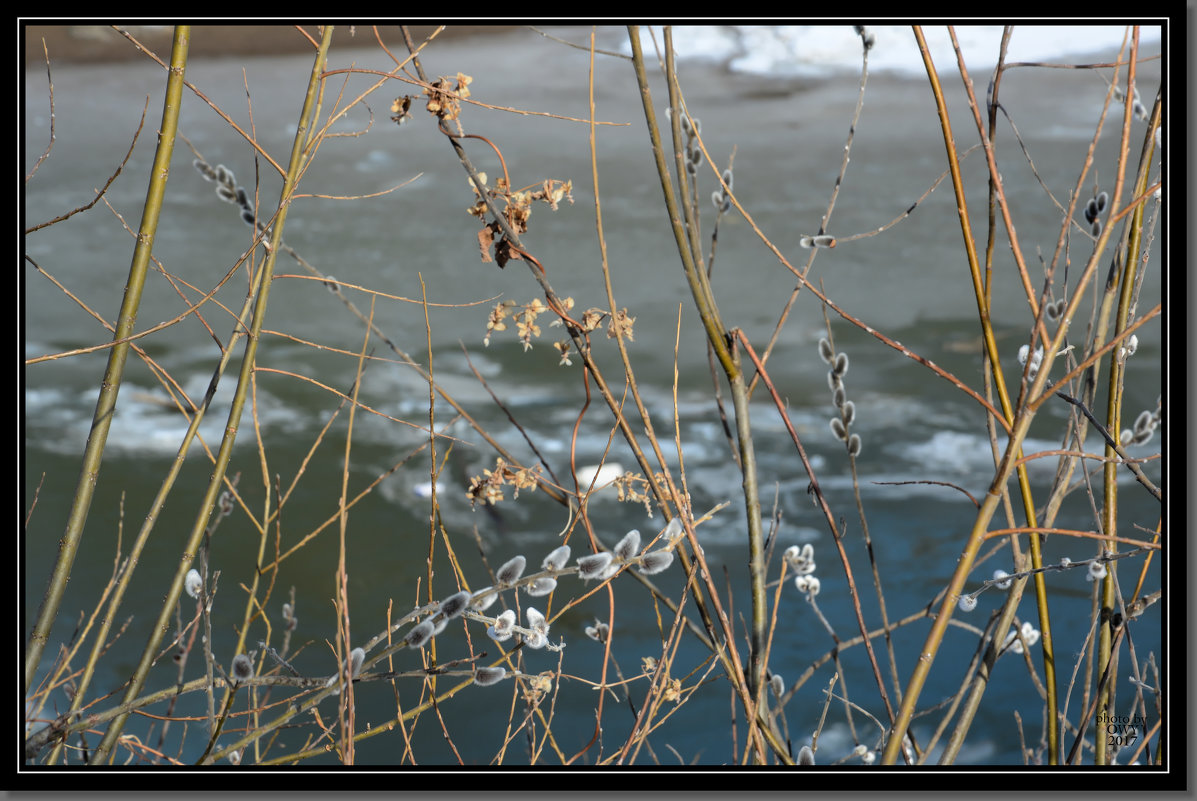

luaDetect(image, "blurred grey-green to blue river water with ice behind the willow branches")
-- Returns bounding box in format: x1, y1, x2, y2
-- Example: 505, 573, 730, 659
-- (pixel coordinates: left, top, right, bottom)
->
23, 24, 1162, 764
